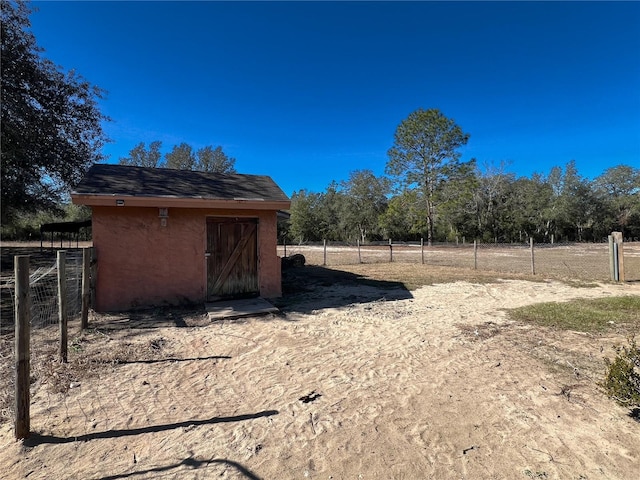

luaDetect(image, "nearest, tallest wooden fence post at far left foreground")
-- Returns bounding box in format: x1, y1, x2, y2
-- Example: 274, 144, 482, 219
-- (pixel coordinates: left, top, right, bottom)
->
14, 255, 31, 440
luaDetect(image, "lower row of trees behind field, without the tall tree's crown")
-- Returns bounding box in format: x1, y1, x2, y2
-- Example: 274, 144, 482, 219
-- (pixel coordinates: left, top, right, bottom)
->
288, 161, 640, 243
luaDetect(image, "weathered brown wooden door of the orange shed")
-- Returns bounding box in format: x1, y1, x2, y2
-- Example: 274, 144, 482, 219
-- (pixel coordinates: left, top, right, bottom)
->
207, 218, 260, 301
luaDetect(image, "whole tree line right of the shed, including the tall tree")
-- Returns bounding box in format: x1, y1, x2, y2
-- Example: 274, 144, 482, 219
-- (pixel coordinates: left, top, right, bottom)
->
288, 109, 640, 244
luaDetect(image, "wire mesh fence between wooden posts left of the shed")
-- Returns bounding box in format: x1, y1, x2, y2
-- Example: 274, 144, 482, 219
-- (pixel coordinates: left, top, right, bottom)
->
0, 250, 83, 436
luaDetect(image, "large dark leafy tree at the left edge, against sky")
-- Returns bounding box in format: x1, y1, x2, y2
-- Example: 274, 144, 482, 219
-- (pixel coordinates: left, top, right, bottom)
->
0, 0, 108, 223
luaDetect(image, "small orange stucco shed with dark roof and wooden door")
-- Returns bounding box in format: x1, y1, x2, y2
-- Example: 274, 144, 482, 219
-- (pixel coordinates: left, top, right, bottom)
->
71, 164, 291, 311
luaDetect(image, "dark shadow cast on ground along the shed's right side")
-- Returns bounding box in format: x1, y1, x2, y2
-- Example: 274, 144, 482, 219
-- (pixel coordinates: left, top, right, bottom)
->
273, 265, 413, 314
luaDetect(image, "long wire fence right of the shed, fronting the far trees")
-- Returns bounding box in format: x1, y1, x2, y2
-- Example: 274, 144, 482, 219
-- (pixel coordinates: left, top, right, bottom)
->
278, 241, 640, 281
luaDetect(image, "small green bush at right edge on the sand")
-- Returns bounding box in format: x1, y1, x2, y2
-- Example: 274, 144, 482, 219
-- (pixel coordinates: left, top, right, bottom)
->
601, 337, 640, 408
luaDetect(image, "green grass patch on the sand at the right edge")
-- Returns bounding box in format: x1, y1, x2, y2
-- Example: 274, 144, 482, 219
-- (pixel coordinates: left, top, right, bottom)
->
509, 296, 640, 333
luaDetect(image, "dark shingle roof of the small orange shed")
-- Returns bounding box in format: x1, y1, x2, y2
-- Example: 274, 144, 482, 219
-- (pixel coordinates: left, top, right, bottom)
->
72, 164, 289, 202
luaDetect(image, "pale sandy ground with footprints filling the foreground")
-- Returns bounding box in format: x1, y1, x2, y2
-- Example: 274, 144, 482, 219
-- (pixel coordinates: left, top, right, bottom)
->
0, 280, 640, 479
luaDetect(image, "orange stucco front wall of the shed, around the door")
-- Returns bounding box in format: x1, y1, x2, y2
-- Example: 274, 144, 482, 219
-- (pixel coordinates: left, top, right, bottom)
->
92, 207, 281, 311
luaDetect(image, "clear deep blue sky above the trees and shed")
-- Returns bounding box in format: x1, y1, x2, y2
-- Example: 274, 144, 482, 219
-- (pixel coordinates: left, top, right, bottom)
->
31, 1, 640, 195
